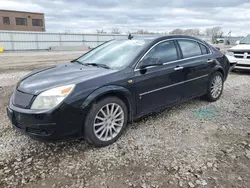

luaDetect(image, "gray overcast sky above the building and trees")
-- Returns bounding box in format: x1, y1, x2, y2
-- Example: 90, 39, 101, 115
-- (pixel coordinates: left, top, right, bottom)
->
0, 0, 250, 35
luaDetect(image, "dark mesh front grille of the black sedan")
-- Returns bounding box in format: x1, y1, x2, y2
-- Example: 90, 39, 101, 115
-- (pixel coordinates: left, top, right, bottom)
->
13, 90, 34, 108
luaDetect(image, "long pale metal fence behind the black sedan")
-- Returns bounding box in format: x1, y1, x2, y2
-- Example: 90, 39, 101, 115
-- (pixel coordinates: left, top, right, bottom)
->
0, 31, 211, 51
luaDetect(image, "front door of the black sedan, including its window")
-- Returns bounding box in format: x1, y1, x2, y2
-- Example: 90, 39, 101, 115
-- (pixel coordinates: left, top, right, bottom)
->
133, 40, 183, 115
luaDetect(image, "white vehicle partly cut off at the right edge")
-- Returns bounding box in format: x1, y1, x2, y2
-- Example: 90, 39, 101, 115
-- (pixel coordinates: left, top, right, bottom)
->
226, 35, 250, 70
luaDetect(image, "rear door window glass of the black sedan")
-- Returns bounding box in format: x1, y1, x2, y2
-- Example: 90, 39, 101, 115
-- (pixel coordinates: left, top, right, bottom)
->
178, 40, 202, 58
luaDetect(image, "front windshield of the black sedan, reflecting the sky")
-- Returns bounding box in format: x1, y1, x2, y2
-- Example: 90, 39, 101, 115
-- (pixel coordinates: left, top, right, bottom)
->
76, 39, 149, 69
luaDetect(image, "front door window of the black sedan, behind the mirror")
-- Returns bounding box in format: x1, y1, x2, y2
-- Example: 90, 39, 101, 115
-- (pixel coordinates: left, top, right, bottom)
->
145, 41, 178, 63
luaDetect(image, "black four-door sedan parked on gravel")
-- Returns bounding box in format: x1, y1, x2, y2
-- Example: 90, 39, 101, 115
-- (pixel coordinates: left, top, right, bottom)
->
7, 35, 230, 146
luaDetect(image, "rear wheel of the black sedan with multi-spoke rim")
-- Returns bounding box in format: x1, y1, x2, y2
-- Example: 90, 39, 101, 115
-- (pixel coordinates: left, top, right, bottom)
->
205, 72, 224, 102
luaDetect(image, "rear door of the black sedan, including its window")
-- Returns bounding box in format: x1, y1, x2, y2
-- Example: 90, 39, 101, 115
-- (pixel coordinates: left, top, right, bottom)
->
177, 39, 214, 98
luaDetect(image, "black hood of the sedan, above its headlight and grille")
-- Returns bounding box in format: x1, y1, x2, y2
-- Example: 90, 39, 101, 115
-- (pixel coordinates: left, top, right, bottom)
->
17, 63, 117, 95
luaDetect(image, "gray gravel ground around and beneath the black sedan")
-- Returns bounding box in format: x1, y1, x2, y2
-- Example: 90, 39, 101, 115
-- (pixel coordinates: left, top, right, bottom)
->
0, 51, 250, 188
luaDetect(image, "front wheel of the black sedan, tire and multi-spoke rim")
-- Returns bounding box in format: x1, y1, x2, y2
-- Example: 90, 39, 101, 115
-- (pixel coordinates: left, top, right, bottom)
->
84, 97, 128, 147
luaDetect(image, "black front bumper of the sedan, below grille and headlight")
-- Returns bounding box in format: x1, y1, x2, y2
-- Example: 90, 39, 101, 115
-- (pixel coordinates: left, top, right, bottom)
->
7, 97, 84, 141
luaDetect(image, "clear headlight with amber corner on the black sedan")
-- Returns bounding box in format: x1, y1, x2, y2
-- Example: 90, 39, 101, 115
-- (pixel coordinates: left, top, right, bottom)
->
31, 84, 75, 110
